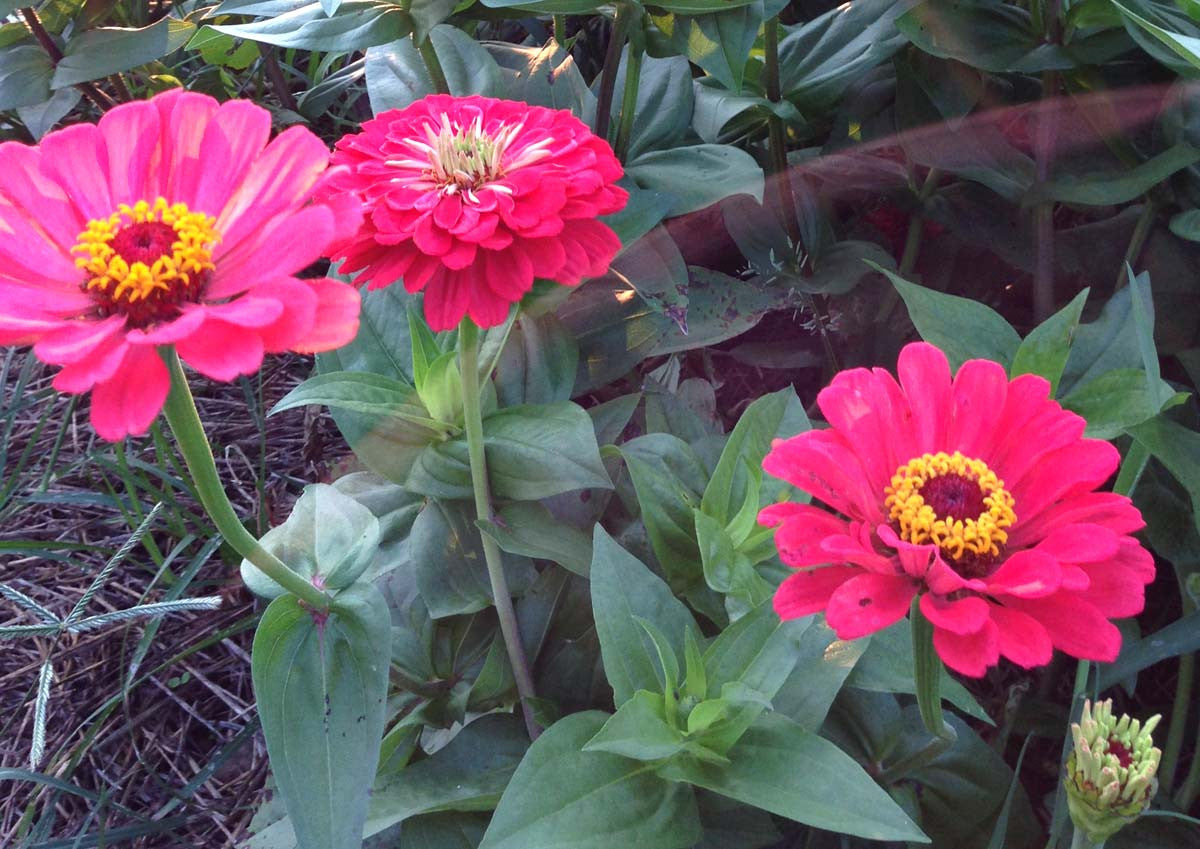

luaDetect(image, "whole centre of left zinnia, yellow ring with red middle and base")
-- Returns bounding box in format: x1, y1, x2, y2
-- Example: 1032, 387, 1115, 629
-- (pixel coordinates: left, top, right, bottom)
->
72, 198, 218, 327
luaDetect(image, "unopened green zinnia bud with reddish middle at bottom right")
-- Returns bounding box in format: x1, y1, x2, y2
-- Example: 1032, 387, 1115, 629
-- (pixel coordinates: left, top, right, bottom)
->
1064, 699, 1163, 844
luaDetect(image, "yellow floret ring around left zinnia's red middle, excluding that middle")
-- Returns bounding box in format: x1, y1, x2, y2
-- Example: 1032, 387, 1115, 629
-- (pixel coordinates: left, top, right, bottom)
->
71, 198, 220, 307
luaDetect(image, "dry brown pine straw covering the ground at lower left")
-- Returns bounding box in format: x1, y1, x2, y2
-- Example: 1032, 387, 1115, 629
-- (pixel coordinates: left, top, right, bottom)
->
0, 356, 337, 849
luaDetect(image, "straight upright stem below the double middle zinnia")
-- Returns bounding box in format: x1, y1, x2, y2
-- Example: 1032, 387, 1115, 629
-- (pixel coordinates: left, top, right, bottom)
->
458, 318, 541, 740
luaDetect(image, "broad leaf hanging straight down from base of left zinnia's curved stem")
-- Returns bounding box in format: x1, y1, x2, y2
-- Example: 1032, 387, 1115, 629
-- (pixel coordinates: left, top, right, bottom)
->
251, 584, 391, 849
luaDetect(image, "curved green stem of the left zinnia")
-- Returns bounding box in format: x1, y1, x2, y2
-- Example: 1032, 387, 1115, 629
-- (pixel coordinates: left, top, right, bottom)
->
163, 349, 330, 610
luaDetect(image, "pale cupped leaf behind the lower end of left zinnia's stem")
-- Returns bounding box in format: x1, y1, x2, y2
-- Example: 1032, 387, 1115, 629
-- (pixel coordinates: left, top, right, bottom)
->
241, 483, 379, 598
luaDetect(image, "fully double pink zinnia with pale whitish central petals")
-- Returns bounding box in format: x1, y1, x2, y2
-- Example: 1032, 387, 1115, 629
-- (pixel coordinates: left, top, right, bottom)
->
330, 95, 628, 331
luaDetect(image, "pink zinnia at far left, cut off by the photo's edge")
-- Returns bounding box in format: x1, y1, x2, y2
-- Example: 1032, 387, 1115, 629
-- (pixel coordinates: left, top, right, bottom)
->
0, 90, 361, 440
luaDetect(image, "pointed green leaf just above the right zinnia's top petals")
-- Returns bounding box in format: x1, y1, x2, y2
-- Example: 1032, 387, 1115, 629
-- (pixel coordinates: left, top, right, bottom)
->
874, 265, 1021, 369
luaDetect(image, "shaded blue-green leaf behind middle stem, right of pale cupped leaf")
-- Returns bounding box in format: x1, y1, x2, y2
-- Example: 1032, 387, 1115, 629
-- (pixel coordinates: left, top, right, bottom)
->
408, 500, 536, 619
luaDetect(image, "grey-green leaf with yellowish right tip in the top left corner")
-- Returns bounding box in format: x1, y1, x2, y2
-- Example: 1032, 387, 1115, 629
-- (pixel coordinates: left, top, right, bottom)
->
50, 17, 196, 89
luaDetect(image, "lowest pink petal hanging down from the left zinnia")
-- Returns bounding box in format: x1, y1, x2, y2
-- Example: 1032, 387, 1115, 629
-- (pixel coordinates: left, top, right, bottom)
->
91, 345, 170, 442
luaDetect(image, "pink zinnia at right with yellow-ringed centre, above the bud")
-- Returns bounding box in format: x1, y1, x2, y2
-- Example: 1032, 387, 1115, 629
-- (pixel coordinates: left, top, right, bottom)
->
758, 343, 1154, 676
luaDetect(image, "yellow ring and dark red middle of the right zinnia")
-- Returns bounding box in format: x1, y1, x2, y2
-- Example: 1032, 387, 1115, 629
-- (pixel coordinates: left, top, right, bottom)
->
884, 451, 1016, 560
